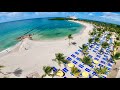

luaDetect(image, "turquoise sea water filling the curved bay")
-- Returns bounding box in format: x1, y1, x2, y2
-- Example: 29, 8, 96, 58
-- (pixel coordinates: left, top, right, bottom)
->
0, 18, 84, 51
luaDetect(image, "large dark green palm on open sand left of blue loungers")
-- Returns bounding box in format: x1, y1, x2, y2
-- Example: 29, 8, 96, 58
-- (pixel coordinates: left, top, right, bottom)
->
53, 53, 69, 67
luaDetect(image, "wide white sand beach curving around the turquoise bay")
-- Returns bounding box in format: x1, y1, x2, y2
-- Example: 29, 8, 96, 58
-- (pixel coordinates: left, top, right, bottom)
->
0, 21, 94, 78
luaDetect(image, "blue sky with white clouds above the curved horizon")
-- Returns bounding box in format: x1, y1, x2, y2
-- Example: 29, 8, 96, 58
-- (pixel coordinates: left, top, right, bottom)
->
0, 12, 120, 25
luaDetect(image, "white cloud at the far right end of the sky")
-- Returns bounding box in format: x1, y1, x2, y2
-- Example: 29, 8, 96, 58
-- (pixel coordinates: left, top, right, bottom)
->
100, 12, 120, 21
